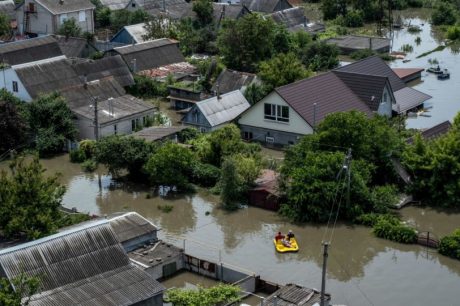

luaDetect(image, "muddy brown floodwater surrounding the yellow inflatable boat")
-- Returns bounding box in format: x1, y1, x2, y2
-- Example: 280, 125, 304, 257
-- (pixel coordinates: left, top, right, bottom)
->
20, 155, 460, 305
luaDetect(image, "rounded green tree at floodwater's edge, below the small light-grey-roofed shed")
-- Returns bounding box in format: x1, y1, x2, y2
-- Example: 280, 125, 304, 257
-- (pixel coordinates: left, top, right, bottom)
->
145, 142, 195, 190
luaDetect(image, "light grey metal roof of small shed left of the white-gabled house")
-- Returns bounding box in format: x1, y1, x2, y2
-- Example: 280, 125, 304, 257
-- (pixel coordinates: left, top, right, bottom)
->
196, 90, 251, 127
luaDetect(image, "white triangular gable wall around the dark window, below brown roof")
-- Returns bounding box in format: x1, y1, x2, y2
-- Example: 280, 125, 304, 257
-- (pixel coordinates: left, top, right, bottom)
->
238, 92, 313, 135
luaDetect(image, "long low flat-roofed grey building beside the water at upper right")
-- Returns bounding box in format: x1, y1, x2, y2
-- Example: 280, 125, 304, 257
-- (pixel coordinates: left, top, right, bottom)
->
326, 35, 390, 54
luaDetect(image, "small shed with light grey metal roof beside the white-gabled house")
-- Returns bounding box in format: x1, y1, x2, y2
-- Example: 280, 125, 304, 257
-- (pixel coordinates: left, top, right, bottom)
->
182, 90, 250, 132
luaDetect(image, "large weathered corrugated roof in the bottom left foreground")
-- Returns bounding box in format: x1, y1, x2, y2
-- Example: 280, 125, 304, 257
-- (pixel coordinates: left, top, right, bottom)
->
0, 220, 164, 306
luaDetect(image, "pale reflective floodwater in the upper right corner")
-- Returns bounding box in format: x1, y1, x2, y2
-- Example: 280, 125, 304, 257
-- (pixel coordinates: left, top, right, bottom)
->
390, 9, 460, 128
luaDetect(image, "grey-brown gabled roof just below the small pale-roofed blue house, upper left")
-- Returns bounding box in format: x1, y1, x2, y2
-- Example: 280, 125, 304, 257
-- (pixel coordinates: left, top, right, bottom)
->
114, 38, 185, 71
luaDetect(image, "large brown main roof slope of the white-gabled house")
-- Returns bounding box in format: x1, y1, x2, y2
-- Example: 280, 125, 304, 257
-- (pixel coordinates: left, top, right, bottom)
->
275, 72, 372, 126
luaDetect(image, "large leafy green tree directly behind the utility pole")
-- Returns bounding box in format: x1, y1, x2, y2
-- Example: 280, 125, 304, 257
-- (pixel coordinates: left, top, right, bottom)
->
280, 151, 373, 222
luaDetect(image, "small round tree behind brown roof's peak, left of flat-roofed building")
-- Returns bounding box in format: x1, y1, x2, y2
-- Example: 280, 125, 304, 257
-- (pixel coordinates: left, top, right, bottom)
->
300, 41, 339, 71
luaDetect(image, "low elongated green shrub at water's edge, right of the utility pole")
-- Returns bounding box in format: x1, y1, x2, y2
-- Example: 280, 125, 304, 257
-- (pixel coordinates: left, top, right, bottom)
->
372, 219, 417, 244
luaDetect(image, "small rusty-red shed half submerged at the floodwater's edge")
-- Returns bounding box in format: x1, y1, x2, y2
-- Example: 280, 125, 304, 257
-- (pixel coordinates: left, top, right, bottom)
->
249, 169, 280, 211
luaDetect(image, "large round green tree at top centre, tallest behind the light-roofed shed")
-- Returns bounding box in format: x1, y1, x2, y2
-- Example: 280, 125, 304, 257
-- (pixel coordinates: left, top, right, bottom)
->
217, 14, 276, 71
